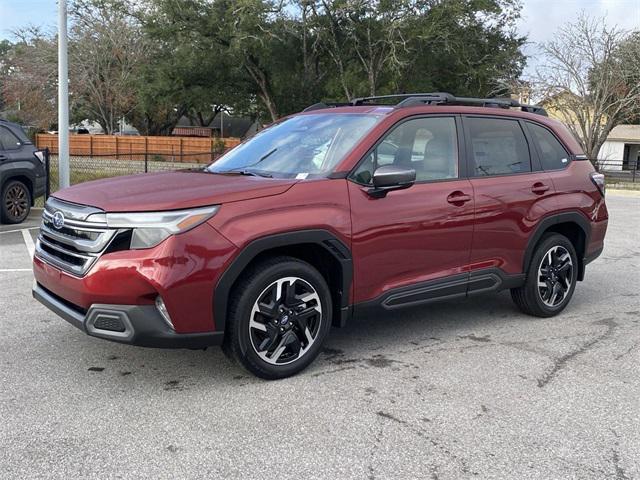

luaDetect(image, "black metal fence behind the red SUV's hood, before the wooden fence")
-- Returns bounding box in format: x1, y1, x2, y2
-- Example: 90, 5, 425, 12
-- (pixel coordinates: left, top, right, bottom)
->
36, 151, 220, 207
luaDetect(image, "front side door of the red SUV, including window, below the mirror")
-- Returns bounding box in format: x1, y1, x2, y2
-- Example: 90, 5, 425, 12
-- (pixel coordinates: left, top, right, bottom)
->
349, 116, 474, 308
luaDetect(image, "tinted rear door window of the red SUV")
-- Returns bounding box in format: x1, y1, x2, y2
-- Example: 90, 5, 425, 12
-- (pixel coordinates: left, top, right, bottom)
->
464, 117, 531, 177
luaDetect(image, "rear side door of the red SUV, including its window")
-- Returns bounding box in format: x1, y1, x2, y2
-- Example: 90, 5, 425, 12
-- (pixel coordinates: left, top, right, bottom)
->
463, 115, 556, 278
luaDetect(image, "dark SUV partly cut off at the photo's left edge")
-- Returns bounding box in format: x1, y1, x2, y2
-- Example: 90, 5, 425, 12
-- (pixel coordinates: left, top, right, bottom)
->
0, 119, 46, 223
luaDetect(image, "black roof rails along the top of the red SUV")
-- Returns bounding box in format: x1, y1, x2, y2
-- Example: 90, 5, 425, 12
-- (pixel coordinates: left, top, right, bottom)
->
303, 92, 547, 116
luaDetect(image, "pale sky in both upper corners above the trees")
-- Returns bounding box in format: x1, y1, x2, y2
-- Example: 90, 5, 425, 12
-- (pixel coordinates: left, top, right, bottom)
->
0, 0, 640, 75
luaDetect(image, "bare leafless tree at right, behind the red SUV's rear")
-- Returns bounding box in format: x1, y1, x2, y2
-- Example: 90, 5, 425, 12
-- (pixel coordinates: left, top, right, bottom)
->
536, 14, 640, 162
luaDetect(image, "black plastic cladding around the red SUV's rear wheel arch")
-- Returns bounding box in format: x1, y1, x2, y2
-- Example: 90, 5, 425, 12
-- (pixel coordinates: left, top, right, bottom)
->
523, 212, 591, 280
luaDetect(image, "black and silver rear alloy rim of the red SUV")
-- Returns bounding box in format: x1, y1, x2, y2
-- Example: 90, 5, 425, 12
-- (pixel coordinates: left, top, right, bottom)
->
538, 245, 573, 308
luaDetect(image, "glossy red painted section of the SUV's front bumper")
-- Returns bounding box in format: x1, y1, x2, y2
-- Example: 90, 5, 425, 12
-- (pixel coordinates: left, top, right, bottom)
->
33, 218, 236, 334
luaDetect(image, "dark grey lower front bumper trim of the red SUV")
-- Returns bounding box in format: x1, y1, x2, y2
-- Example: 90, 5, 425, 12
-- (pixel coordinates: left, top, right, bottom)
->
32, 282, 224, 348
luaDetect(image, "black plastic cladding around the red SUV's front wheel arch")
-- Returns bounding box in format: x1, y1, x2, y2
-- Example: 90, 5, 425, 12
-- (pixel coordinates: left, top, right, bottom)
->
213, 229, 353, 331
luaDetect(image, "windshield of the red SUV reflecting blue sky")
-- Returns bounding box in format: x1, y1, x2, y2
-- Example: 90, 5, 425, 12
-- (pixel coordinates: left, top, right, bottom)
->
207, 113, 380, 178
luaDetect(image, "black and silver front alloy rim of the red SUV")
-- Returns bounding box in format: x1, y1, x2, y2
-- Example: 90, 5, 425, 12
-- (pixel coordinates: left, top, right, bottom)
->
249, 277, 323, 365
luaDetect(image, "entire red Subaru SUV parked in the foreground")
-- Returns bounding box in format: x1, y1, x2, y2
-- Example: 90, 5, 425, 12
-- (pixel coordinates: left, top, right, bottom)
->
33, 93, 608, 379
